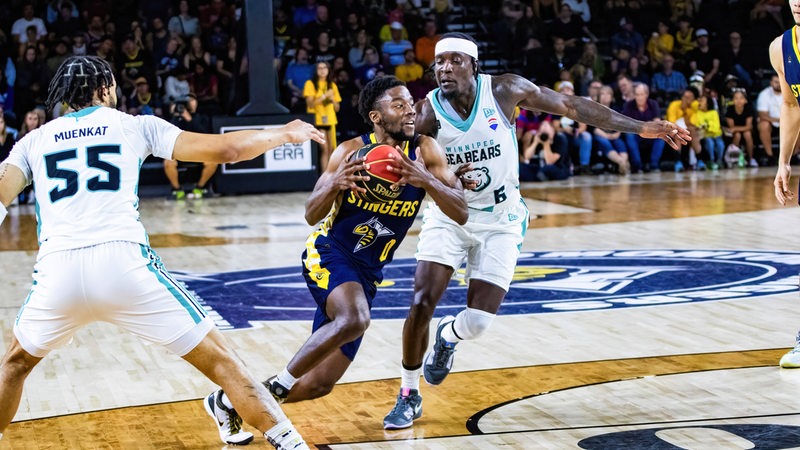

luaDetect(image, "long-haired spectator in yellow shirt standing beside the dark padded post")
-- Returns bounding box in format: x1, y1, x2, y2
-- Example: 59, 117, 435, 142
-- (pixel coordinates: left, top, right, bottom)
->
303, 62, 342, 172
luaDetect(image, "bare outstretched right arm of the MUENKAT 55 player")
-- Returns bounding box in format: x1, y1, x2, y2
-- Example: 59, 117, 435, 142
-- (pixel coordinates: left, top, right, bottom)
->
172, 120, 325, 163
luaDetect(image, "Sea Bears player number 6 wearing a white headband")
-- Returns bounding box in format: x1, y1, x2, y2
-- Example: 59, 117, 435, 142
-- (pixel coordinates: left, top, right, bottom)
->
384, 33, 690, 429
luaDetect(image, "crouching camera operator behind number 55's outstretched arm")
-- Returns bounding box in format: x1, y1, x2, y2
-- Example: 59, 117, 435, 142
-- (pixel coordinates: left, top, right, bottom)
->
164, 93, 218, 200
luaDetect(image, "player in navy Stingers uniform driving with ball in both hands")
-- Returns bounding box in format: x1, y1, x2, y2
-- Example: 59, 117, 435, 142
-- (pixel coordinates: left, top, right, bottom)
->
206, 76, 467, 428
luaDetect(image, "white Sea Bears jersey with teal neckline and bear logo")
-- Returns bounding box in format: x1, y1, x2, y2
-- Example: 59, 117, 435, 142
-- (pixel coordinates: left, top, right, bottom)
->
428, 74, 520, 211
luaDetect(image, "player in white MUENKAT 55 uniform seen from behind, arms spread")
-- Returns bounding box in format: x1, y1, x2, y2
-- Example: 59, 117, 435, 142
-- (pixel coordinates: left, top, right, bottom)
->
0, 56, 324, 449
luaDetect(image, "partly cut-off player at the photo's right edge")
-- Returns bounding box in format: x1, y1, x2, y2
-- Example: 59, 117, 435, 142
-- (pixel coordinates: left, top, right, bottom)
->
769, 1, 800, 369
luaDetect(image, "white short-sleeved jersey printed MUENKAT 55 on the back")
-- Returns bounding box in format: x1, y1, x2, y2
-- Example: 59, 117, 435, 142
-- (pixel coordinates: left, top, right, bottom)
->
6, 106, 181, 258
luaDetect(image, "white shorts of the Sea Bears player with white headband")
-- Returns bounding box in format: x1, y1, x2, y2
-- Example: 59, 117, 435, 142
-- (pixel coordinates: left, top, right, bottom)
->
415, 199, 529, 292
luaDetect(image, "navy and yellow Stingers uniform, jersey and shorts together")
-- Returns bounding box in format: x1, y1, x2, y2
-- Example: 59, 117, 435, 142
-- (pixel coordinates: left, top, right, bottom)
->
303, 134, 425, 360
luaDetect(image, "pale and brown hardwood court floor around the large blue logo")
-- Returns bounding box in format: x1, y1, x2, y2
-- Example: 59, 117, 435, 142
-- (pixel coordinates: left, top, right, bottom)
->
0, 168, 800, 449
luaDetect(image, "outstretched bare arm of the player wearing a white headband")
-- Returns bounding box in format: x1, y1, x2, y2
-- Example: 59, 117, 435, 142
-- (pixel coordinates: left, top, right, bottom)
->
493, 74, 692, 150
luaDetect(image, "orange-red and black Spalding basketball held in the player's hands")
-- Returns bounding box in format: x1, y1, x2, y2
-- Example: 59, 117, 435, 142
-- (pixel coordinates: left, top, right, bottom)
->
352, 144, 403, 203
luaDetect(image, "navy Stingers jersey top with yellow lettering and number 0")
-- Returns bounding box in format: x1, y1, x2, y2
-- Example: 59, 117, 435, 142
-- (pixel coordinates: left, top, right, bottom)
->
304, 134, 425, 272
